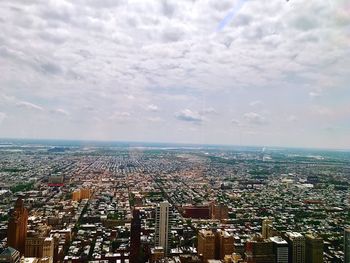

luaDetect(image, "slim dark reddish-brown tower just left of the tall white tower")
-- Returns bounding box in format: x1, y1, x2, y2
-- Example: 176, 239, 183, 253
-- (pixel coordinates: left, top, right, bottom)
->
130, 209, 141, 263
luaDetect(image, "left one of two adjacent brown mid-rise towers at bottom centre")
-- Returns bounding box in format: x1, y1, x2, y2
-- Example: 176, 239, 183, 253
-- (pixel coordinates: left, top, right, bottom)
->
197, 229, 216, 262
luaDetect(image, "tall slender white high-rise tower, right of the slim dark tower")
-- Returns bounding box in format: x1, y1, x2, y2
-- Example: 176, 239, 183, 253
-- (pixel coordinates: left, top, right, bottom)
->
155, 201, 170, 255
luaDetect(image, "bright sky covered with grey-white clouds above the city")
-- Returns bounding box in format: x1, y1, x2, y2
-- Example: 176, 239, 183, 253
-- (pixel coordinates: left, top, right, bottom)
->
0, 0, 350, 149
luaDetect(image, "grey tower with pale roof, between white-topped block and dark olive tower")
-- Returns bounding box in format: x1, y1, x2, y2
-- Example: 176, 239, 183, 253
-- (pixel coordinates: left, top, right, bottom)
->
286, 232, 305, 263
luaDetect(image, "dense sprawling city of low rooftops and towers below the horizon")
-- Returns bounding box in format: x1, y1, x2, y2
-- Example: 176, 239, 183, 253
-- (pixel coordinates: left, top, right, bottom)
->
0, 140, 350, 263
